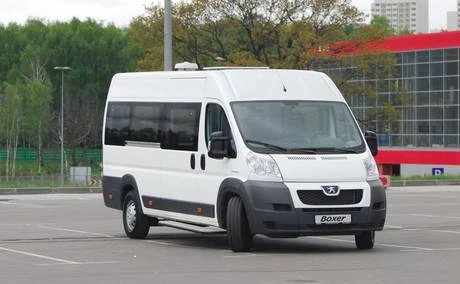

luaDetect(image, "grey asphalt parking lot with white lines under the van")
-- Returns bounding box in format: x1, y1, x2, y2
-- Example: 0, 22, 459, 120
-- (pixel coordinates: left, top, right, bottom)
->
0, 187, 460, 284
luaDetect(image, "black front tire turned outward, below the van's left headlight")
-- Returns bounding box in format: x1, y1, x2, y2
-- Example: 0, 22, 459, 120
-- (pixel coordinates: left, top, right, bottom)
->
227, 196, 252, 252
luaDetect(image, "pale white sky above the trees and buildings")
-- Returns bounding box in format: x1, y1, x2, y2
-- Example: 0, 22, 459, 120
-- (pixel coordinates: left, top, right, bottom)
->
0, 0, 457, 31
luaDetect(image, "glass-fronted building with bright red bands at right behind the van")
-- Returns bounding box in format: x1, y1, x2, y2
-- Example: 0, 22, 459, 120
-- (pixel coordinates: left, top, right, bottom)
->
317, 31, 460, 175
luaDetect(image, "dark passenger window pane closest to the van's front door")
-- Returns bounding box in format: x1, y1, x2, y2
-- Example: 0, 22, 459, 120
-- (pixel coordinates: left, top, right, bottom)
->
161, 103, 201, 151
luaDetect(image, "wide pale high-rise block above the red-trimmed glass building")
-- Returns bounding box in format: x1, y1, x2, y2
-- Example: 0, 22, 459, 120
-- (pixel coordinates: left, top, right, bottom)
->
371, 0, 428, 33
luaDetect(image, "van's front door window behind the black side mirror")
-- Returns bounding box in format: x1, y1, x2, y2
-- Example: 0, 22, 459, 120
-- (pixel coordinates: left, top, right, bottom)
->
205, 104, 232, 145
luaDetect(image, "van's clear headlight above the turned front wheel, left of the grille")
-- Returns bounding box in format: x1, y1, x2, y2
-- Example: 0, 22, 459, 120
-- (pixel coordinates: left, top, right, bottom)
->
246, 152, 281, 180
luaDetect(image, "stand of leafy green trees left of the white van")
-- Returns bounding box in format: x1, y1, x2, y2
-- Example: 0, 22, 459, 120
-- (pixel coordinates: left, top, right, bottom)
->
0, 19, 138, 173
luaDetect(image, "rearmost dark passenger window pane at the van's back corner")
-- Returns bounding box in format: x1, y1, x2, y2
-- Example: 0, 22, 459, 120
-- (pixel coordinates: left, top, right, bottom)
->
105, 103, 131, 146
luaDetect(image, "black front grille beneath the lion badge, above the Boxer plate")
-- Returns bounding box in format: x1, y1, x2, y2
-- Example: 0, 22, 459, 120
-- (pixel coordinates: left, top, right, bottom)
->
297, 189, 363, 205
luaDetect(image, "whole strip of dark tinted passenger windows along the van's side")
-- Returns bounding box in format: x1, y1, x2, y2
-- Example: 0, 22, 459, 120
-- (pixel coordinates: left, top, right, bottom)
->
105, 102, 201, 151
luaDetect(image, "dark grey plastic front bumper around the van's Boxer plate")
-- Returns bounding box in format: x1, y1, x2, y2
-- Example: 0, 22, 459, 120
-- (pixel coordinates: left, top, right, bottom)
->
243, 181, 386, 237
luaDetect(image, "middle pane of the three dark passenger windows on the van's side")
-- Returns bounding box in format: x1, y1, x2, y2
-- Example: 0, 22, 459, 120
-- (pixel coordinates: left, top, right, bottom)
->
130, 103, 161, 143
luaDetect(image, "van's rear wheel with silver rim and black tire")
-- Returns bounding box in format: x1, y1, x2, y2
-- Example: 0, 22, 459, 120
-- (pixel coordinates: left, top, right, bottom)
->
123, 191, 152, 239
